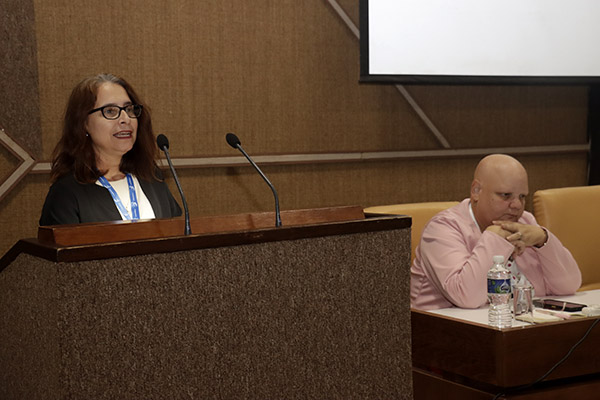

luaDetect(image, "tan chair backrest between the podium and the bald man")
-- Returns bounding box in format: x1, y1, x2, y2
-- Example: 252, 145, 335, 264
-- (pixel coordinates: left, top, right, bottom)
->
364, 201, 458, 265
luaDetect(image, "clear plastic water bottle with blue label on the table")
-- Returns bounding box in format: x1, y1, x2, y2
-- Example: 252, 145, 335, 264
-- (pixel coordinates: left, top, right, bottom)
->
488, 256, 512, 328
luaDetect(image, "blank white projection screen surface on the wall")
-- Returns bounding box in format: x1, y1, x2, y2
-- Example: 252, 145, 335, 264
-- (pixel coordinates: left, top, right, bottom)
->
361, 0, 600, 81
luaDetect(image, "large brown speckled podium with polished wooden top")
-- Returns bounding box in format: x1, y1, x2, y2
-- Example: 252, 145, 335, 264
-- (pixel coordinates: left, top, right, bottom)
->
0, 207, 412, 399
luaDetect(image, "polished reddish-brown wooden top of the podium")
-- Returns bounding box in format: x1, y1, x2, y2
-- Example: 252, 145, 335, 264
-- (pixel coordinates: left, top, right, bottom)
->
0, 206, 411, 272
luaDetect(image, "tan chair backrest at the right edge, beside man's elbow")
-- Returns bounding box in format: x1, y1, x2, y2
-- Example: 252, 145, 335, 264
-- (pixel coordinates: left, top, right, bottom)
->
533, 186, 600, 290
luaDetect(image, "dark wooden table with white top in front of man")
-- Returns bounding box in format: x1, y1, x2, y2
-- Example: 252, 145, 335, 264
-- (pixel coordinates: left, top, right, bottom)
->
411, 290, 600, 399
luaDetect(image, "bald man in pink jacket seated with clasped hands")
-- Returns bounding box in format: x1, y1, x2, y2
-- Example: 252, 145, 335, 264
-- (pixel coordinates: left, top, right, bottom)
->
411, 154, 581, 310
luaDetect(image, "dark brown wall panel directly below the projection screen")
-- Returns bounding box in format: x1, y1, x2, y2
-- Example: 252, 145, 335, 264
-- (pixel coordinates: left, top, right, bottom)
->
410, 86, 588, 148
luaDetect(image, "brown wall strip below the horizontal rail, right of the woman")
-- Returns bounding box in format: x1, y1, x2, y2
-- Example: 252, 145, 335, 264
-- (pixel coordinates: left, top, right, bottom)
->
170, 155, 587, 220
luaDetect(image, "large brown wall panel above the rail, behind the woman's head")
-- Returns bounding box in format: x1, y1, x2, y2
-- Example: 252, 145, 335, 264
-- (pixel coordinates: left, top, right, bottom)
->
36, 0, 435, 158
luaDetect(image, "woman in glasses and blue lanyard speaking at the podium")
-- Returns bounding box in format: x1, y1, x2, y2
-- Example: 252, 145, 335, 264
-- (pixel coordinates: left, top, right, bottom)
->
40, 74, 181, 225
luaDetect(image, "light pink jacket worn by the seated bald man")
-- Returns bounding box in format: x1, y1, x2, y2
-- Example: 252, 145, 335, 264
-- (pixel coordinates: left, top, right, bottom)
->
410, 199, 581, 310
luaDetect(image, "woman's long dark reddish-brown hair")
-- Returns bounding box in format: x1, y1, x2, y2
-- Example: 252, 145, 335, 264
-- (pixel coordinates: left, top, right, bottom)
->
52, 74, 160, 183
